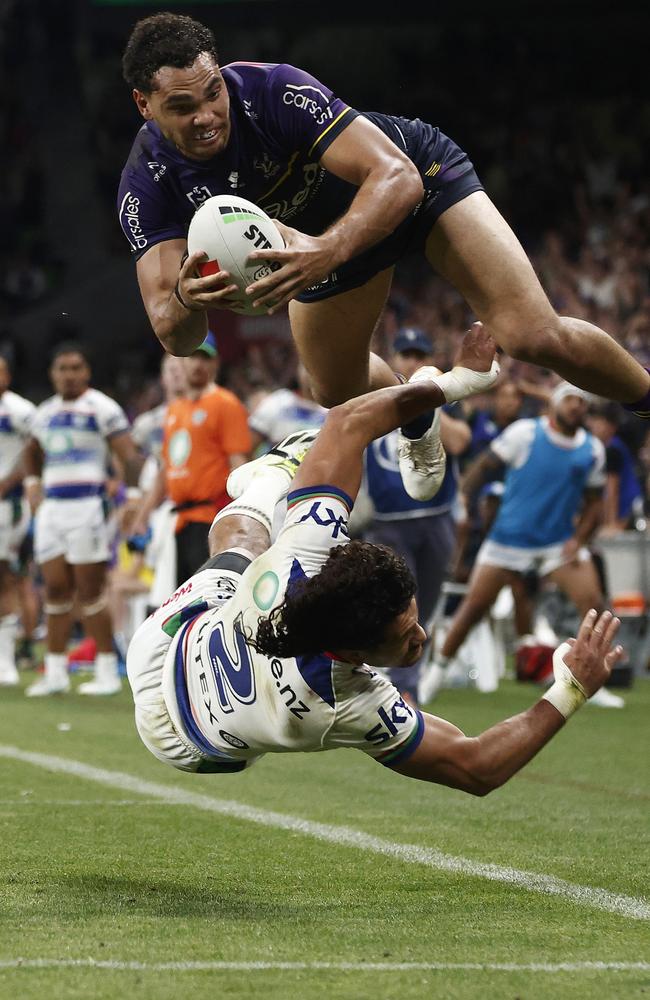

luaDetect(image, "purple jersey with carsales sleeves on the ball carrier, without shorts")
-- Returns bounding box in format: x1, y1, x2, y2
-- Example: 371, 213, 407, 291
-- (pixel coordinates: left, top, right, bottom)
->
118, 63, 358, 259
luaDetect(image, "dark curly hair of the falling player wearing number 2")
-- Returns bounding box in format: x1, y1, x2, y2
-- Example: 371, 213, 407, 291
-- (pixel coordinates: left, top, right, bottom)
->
253, 541, 415, 657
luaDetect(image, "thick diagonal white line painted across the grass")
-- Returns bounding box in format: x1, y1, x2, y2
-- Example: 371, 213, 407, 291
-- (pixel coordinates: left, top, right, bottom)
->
0, 745, 650, 920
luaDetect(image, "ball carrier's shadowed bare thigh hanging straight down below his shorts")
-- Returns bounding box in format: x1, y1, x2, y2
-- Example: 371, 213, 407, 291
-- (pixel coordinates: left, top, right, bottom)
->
289, 268, 393, 406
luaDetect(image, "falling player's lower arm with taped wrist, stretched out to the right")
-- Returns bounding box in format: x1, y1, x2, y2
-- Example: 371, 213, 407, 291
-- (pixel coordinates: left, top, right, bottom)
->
395, 609, 623, 795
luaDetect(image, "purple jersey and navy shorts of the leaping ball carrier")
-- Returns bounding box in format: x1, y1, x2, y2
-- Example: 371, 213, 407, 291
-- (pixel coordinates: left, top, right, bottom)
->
118, 62, 482, 302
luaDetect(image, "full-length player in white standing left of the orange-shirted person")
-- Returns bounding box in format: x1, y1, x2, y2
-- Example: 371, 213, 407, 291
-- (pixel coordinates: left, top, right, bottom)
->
25, 344, 142, 697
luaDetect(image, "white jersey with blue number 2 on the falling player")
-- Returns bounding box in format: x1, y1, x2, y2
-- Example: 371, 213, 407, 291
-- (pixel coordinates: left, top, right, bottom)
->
128, 486, 424, 771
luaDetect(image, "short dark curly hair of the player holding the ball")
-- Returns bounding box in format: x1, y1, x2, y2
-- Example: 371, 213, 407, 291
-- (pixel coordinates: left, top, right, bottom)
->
122, 13, 218, 94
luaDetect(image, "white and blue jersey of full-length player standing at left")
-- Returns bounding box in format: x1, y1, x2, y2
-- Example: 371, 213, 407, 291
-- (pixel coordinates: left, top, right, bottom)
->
32, 389, 129, 500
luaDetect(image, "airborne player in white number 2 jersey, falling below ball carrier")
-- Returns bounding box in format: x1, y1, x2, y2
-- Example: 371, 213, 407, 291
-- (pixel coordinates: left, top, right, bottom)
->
127, 328, 621, 795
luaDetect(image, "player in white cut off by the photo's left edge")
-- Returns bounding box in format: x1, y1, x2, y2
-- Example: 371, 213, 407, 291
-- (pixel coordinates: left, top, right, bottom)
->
0, 357, 36, 687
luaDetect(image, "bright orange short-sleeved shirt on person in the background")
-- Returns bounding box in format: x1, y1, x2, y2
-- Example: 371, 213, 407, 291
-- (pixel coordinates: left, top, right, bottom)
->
162, 385, 251, 531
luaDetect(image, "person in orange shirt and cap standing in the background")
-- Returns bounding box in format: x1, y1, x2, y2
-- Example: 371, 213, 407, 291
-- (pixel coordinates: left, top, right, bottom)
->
162, 332, 251, 584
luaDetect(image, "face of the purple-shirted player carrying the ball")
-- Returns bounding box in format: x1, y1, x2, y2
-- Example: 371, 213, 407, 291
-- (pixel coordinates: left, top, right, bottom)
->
133, 52, 230, 160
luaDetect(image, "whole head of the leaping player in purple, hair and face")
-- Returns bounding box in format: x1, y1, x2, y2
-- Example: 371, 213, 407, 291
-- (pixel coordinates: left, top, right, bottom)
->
122, 13, 230, 160
